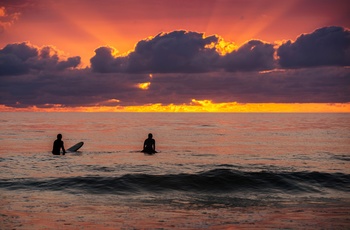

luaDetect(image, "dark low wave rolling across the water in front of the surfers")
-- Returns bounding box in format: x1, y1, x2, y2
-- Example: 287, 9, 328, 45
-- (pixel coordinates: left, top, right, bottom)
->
0, 169, 350, 194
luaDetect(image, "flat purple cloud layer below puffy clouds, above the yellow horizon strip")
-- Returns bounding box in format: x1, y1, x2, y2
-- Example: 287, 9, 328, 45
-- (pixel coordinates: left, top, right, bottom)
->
0, 67, 350, 107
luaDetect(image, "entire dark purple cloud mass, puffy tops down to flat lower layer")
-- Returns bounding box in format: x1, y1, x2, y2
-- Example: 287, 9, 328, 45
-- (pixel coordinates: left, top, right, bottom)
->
0, 27, 350, 107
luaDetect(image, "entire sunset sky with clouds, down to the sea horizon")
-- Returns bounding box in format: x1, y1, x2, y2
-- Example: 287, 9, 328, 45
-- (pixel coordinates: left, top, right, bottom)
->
0, 0, 350, 112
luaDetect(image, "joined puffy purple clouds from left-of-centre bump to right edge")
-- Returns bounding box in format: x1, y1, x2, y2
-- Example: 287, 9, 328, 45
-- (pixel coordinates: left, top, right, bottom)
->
91, 26, 350, 73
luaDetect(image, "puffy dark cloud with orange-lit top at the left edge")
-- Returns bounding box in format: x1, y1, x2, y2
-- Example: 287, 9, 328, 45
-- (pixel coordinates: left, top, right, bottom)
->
0, 42, 80, 76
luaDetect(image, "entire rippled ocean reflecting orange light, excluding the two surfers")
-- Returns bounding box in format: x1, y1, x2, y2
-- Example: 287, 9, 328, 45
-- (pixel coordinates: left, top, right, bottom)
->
0, 113, 350, 229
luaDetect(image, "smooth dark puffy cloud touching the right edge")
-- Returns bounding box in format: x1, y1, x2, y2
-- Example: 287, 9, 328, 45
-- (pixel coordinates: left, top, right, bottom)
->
277, 26, 350, 68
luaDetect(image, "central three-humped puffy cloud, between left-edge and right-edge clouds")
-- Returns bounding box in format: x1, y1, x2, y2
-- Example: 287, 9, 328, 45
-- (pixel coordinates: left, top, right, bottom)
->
91, 31, 274, 73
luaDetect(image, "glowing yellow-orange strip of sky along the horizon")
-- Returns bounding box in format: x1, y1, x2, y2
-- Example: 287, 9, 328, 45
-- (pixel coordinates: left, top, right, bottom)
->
0, 99, 350, 113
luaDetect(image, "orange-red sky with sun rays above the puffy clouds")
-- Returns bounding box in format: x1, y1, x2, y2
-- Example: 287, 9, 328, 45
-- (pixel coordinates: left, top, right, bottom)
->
0, 0, 350, 65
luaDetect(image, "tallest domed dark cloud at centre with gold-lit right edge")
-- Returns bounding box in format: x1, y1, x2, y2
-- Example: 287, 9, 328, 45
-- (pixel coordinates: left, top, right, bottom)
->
129, 31, 219, 73
